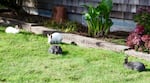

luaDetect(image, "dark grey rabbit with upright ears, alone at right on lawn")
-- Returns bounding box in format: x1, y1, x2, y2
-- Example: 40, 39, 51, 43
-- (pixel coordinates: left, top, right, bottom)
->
124, 56, 145, 72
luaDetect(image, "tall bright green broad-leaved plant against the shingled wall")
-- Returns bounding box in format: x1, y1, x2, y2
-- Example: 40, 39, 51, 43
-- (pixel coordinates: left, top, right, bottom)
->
84, 0, 113, 37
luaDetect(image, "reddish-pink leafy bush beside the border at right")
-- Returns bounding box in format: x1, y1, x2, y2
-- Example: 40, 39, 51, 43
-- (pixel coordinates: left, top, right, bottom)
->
126, 25, 150, 53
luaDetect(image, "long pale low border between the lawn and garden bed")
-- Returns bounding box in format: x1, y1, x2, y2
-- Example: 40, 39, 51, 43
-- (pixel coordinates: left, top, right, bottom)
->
0, 17, 150, 61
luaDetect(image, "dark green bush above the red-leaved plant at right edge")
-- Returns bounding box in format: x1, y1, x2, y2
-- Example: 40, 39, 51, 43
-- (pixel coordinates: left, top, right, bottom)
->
133, 7, 150, 34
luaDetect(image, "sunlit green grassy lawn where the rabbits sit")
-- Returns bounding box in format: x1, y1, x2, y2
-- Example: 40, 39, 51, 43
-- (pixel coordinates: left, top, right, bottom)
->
0, 27, 150, 83
